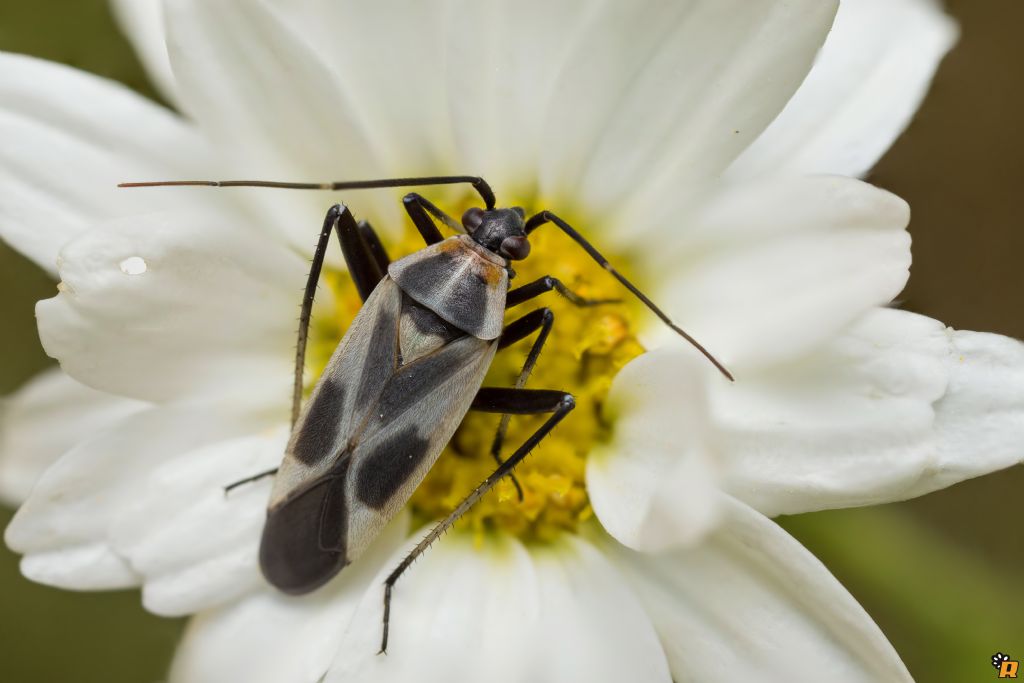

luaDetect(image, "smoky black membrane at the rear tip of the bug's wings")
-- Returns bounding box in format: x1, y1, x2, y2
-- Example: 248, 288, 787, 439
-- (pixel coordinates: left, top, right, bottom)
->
259, 457, 349, 595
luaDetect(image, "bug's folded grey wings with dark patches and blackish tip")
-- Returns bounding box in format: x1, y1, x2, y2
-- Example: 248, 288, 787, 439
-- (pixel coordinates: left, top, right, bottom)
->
260, 278, 497, 593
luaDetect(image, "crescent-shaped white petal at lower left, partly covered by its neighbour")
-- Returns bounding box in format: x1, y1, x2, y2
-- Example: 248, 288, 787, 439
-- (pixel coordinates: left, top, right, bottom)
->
5, 403, 260, 589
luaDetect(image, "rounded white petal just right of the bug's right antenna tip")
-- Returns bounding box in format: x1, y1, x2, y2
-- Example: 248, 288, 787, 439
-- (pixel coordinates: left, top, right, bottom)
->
648, 176, 910, 368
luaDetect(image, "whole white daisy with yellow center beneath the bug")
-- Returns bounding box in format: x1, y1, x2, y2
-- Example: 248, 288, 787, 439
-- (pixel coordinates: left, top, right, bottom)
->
0, 0, 1024, 681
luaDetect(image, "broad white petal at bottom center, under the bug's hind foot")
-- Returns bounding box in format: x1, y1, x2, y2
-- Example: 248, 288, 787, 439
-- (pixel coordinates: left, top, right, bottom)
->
325, 533, 670, 683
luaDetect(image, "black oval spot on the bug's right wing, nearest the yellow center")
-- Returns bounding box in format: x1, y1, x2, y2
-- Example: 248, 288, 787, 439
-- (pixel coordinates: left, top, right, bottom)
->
355, 425, 429, 510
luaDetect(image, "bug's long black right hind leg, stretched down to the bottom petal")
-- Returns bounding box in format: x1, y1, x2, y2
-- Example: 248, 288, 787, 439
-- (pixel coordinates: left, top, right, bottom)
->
380, 387, 575, 653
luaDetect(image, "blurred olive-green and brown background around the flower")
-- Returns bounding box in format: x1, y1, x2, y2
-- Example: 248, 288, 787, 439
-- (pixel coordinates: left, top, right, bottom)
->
0, 0, 1024, 683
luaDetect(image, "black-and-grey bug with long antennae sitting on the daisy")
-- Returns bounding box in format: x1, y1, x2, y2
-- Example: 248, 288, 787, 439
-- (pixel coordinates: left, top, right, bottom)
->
122, 176, 732, 652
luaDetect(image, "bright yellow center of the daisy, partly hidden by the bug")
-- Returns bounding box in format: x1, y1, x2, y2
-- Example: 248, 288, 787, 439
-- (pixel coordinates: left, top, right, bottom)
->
307, 200, 644, 541
